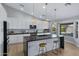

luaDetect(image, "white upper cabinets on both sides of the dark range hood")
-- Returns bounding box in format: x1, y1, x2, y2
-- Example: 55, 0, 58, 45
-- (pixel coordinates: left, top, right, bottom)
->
8, 17, 48, 29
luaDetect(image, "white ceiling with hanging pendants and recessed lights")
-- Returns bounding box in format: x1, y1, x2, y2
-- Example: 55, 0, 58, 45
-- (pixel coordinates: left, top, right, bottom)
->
3, 3, 79, 20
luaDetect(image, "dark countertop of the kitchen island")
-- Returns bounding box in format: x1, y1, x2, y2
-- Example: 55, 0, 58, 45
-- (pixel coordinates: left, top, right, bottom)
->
24, 33, 60, 42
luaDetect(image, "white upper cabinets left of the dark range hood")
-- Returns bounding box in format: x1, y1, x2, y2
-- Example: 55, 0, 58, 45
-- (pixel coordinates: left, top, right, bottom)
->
8, 17, 32, 29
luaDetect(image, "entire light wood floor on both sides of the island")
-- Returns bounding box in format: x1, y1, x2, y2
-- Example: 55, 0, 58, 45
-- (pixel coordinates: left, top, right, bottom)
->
8, 42, 79, 56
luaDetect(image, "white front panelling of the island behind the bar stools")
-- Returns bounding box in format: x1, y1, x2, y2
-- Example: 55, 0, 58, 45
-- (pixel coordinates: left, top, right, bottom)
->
28, 38, 57, 56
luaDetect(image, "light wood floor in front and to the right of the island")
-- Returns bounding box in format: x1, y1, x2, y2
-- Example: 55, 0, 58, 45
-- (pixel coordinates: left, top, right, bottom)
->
47, 42, 79, 56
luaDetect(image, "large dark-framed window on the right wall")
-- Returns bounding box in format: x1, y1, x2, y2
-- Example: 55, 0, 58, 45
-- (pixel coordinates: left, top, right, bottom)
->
60, 23, 73, 36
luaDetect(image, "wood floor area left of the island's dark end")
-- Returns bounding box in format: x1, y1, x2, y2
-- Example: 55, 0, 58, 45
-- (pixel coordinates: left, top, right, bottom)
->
8, 43, 24, 56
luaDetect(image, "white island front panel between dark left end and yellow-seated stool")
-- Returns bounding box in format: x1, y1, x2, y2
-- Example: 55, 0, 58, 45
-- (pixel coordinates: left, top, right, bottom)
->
28, 41, 39, 56
